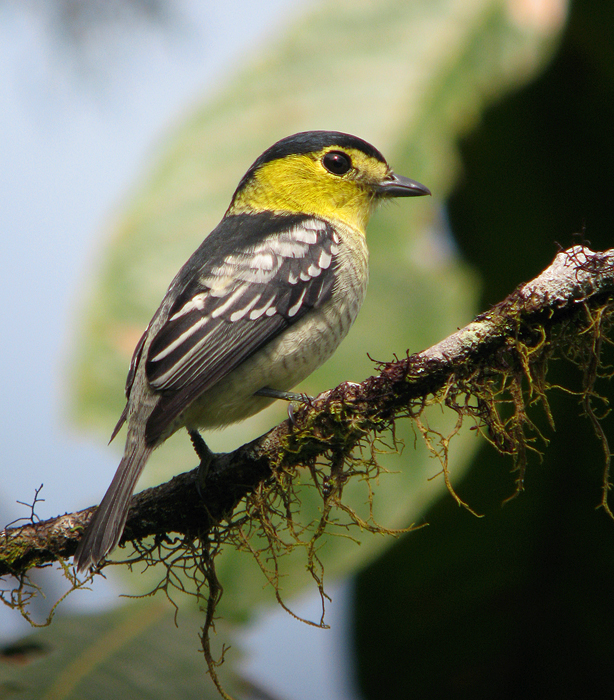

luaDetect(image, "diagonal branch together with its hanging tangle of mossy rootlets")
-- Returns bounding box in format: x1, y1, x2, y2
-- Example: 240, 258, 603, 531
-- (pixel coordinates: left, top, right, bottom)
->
0, 246, 614, 644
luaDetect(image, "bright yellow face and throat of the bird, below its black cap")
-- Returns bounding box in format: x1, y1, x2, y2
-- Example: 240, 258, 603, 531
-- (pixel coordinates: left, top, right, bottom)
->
228, 145, 391, 233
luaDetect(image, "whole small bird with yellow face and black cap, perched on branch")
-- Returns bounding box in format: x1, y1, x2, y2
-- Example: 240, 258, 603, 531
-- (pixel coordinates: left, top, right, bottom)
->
74, 131, 430, 571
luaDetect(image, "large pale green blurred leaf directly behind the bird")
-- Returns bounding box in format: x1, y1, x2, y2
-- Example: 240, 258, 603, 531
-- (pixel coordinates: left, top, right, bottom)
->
68, 0, 559, 616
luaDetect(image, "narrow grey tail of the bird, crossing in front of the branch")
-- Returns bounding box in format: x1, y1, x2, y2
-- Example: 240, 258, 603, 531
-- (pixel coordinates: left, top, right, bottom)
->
74, 434, 153, 571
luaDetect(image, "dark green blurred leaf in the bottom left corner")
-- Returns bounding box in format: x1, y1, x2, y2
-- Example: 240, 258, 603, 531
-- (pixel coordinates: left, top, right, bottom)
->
0, 600, 243, 700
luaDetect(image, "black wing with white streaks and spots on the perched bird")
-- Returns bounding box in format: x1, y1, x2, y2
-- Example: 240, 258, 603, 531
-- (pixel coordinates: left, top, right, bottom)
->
141, 215, 339, 444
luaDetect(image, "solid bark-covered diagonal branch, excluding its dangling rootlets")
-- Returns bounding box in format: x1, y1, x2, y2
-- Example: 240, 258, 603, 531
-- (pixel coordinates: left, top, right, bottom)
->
0, 246, 614, 576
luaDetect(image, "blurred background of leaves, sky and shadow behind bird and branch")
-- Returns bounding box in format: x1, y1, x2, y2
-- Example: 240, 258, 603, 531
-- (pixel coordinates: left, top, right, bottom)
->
0, 0, 614, 700
